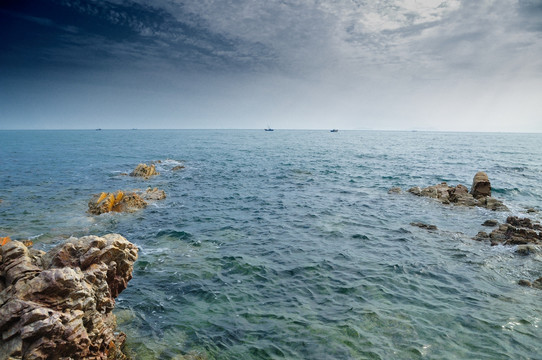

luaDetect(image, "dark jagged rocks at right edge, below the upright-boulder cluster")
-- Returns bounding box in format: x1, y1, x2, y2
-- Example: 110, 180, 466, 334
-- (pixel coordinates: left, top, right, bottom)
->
475, 216, 542, 245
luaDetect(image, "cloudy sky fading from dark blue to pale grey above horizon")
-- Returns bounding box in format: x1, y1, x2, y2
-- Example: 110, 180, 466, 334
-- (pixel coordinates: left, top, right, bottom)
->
0, 0, 542, 132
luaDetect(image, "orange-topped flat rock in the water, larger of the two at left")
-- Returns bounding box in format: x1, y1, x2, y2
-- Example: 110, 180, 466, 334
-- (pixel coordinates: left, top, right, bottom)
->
88, 188, 166, 215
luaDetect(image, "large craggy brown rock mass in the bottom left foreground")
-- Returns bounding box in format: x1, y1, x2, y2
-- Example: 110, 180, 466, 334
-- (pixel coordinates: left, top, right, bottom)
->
0, 234, 137, 360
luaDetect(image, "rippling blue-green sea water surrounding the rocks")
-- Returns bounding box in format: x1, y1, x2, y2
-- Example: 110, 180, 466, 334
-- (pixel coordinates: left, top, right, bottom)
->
0, 130, 542, 359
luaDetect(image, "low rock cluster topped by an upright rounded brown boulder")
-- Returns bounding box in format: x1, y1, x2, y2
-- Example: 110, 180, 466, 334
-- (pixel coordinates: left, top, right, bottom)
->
408, 172, 508, 211
